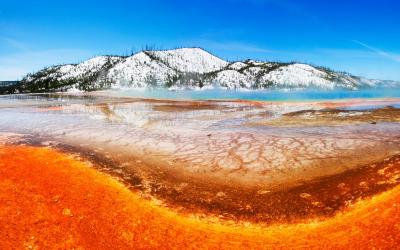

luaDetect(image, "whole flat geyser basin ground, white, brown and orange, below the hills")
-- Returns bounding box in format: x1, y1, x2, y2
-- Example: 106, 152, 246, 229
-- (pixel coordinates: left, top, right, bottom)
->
0, 94, 400, 248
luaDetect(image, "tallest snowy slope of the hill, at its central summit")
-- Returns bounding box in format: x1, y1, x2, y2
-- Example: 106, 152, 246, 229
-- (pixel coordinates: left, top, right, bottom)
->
108, 48, 228, 88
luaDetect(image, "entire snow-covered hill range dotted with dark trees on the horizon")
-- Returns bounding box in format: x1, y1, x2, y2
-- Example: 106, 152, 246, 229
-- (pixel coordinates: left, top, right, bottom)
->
3, 48, 394, 92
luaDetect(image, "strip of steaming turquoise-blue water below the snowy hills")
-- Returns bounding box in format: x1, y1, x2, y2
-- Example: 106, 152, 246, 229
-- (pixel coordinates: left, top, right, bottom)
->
111, 88, 400, 101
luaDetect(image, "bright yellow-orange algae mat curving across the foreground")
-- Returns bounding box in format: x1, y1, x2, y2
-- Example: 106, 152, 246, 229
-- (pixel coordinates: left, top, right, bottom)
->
0, 146, 400, 249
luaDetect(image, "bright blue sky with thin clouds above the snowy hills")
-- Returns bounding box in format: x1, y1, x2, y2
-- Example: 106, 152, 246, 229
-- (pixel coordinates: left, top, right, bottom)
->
0, 0, 400, 80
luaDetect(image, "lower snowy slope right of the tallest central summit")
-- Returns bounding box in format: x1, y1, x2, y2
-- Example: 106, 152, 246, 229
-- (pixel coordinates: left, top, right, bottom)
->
208, 61, 365, 89
